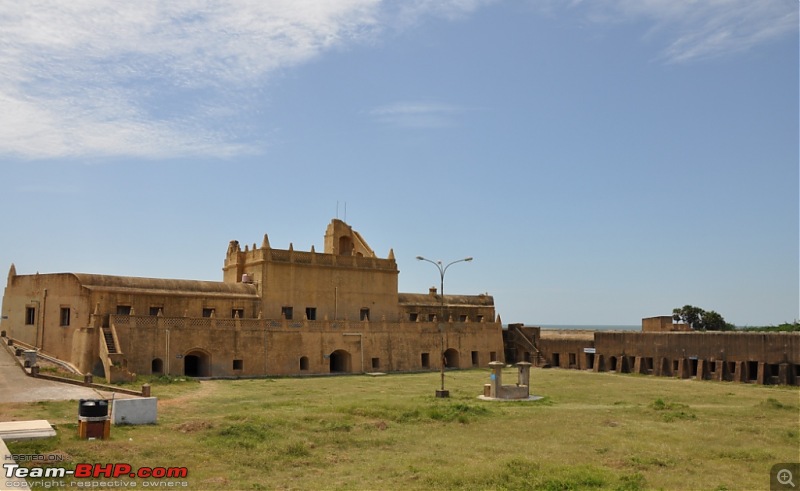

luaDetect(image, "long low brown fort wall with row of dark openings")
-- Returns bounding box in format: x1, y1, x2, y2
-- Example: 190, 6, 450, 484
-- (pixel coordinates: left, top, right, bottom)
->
503, 322, 800, 385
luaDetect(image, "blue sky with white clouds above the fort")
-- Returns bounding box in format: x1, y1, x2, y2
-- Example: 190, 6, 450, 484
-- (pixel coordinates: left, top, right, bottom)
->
0, 0, 800, 326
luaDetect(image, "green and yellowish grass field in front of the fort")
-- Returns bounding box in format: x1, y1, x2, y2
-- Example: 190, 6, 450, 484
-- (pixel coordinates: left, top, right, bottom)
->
0, 369, 800, 490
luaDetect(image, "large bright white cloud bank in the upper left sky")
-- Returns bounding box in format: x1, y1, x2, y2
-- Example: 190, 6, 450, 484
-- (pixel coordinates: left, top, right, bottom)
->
0, 0, 378, 159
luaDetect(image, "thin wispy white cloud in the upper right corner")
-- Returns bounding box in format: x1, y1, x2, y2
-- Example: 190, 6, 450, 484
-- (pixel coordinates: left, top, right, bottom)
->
564, 0, 798, 63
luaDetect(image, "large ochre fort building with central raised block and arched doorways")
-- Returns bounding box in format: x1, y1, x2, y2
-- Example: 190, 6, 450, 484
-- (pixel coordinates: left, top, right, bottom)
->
0, 219, 503, 381
